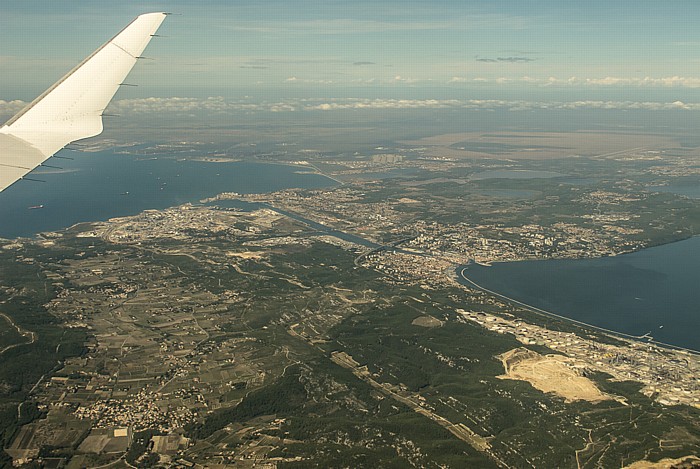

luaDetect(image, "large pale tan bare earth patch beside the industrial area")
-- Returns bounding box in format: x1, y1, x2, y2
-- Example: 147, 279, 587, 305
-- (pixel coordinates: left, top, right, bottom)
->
497, 347, 612, 402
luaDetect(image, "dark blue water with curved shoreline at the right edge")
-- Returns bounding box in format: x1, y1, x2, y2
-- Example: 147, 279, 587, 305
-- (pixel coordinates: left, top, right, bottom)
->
464, 237, 700, 351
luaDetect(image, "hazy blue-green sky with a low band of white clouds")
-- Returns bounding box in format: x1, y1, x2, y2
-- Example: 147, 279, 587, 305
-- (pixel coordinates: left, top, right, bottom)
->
0, 0, 700, 113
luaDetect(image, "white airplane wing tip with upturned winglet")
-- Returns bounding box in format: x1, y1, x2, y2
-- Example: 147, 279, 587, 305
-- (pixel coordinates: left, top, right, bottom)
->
0, 13, 167, 192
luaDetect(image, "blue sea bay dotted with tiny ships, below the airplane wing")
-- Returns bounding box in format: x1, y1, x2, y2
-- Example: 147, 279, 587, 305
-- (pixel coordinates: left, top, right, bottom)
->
0, 151, 336, 238
